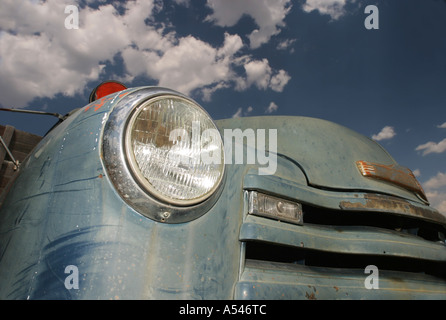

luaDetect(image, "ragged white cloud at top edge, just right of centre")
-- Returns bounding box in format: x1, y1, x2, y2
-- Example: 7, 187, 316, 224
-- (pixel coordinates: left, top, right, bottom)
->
206, 0, 291, 49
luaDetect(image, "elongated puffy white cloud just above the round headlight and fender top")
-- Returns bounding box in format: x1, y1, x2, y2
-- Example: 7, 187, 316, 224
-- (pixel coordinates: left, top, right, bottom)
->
122, 34, 290, 100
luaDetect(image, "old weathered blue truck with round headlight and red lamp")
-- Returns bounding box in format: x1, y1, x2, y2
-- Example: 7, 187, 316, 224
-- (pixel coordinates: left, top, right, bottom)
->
0, 82, 446, 300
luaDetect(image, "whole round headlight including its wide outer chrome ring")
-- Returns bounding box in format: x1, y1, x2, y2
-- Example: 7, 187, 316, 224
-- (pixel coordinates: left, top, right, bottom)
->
102, 87, 225, 223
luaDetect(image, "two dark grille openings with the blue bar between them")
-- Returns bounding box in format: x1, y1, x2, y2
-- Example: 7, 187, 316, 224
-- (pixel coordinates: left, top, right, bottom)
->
241, 192, 446, 279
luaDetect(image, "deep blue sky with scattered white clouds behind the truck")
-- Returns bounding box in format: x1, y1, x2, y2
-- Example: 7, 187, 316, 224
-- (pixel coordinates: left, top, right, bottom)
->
0, 0, 446, 214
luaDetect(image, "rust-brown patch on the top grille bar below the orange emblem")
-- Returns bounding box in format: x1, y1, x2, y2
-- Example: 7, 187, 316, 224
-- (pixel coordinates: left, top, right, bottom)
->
339, 194, 446, 226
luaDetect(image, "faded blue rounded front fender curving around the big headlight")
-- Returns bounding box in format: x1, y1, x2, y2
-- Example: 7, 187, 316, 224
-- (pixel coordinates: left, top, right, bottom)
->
0, 90, 243, 299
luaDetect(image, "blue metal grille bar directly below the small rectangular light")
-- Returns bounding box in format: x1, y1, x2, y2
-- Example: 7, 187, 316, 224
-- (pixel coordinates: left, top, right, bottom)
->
240, 216, 446, 262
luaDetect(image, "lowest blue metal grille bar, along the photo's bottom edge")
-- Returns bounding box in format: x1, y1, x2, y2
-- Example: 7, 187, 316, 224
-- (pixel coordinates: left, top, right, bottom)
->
235, 261, 446, 300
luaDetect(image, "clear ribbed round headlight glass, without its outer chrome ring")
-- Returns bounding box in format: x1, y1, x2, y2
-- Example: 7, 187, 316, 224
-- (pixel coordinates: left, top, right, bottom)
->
125, 95, 224, 206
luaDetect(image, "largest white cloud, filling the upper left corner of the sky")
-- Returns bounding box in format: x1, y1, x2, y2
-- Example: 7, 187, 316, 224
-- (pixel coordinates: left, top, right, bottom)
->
0, 0, 145, 107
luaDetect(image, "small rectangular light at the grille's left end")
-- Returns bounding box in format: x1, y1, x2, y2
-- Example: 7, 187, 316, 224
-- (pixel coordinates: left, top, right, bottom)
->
248, 191, 303, 225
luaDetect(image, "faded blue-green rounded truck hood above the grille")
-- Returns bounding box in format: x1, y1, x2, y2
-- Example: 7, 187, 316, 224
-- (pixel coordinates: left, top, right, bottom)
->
216, 116, 427, 204
